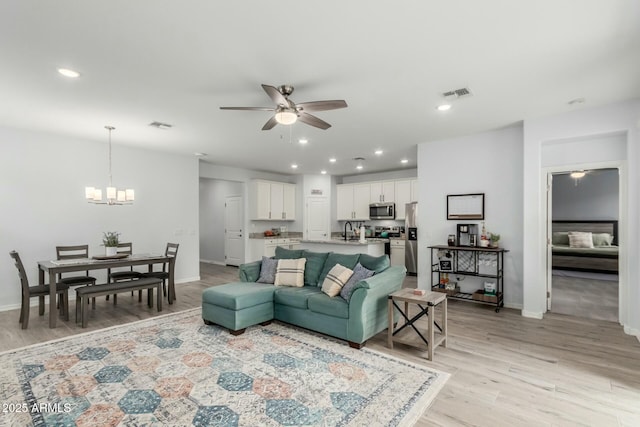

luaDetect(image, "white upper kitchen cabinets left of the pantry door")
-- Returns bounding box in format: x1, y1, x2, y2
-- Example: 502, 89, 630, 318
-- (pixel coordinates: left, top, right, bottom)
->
249, 180, 296, 221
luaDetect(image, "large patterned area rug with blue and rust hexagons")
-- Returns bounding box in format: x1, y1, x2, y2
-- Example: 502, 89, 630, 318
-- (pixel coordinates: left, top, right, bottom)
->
0, 309, 449, 427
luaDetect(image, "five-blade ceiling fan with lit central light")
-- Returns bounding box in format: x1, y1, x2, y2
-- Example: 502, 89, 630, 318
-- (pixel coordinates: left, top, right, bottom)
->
220, 84, 347, 130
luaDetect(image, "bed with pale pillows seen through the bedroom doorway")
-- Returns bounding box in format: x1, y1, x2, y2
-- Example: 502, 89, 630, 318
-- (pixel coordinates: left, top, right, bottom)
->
551, 220, 618, 274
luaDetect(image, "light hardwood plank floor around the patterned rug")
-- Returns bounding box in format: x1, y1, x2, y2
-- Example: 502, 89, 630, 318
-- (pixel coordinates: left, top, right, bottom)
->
0, 264, 640, 426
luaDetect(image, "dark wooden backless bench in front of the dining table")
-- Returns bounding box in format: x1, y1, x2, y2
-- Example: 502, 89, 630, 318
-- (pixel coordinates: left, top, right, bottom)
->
76, 277, 162, 328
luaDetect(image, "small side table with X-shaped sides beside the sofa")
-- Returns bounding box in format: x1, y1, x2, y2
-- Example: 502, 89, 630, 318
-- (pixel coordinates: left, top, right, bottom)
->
387, 289, 447, 360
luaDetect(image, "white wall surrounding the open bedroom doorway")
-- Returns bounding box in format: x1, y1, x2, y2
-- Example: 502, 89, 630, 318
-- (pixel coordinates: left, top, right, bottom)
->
523, 100, 640, 335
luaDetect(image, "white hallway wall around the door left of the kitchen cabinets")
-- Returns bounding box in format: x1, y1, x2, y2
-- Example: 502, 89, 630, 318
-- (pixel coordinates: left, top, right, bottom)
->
200, 178, 244, 264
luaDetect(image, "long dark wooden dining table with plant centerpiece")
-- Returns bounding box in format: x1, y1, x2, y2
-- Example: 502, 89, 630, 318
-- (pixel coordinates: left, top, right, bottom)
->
38, 254, 175, 328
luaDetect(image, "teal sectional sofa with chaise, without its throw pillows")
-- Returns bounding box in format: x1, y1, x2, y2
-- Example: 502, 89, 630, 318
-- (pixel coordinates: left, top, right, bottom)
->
202, 247, 406, 348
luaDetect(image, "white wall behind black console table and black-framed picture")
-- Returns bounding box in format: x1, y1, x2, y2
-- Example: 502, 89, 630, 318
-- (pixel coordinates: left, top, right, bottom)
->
418, 126, 523, 307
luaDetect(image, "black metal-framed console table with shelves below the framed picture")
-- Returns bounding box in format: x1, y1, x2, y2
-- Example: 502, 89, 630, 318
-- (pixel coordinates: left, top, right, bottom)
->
429, 245, 509, 313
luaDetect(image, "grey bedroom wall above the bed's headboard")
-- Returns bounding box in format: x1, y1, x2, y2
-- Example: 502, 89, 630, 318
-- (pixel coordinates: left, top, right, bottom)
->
551, 169, 620, 221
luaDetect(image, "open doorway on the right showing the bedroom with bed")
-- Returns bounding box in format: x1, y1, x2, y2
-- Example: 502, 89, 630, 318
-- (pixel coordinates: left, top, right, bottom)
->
547, 166, 621, 322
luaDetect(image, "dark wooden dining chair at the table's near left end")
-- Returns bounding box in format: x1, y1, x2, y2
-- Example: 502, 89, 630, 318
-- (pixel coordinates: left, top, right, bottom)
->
9, 251, 69, 329
